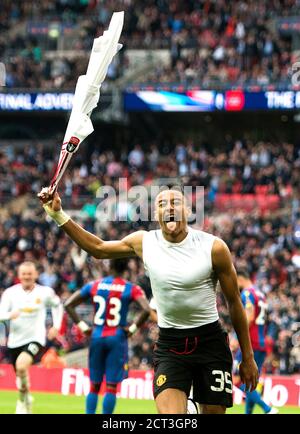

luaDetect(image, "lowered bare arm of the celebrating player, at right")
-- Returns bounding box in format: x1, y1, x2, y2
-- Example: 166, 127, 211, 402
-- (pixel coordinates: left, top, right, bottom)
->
212, 239, 258, 391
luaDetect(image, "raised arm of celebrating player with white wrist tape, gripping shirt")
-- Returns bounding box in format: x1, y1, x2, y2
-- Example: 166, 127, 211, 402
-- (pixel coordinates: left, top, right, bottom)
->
38, 189, 145, 259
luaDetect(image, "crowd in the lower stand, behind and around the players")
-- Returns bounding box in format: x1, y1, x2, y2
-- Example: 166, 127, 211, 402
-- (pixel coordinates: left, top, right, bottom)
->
0, 140, 300, 374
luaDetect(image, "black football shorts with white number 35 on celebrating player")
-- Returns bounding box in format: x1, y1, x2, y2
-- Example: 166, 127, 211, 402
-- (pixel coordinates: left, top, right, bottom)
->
153, 321, 232, 407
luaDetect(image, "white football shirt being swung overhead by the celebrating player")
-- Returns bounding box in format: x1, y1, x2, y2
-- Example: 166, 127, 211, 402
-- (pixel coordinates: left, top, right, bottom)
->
48, 11, 124, 195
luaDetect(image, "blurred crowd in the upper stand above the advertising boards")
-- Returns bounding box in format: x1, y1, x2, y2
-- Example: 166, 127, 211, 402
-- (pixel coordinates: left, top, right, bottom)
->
0, 0, 299, 89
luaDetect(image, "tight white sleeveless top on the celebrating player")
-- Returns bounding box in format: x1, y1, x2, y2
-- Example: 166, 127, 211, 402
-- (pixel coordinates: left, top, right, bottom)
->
143, 227, 219, 329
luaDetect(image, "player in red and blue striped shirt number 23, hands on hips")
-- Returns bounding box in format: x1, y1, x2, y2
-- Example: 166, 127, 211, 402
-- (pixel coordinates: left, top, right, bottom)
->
65, 259, 150, 414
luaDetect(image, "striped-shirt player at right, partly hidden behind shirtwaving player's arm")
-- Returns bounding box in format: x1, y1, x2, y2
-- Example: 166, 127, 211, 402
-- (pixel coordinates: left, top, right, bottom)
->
236, 270, 278, 414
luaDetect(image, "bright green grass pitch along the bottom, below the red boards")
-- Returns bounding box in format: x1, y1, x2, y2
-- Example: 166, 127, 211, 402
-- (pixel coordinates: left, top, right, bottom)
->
0, 391, 300, 414
